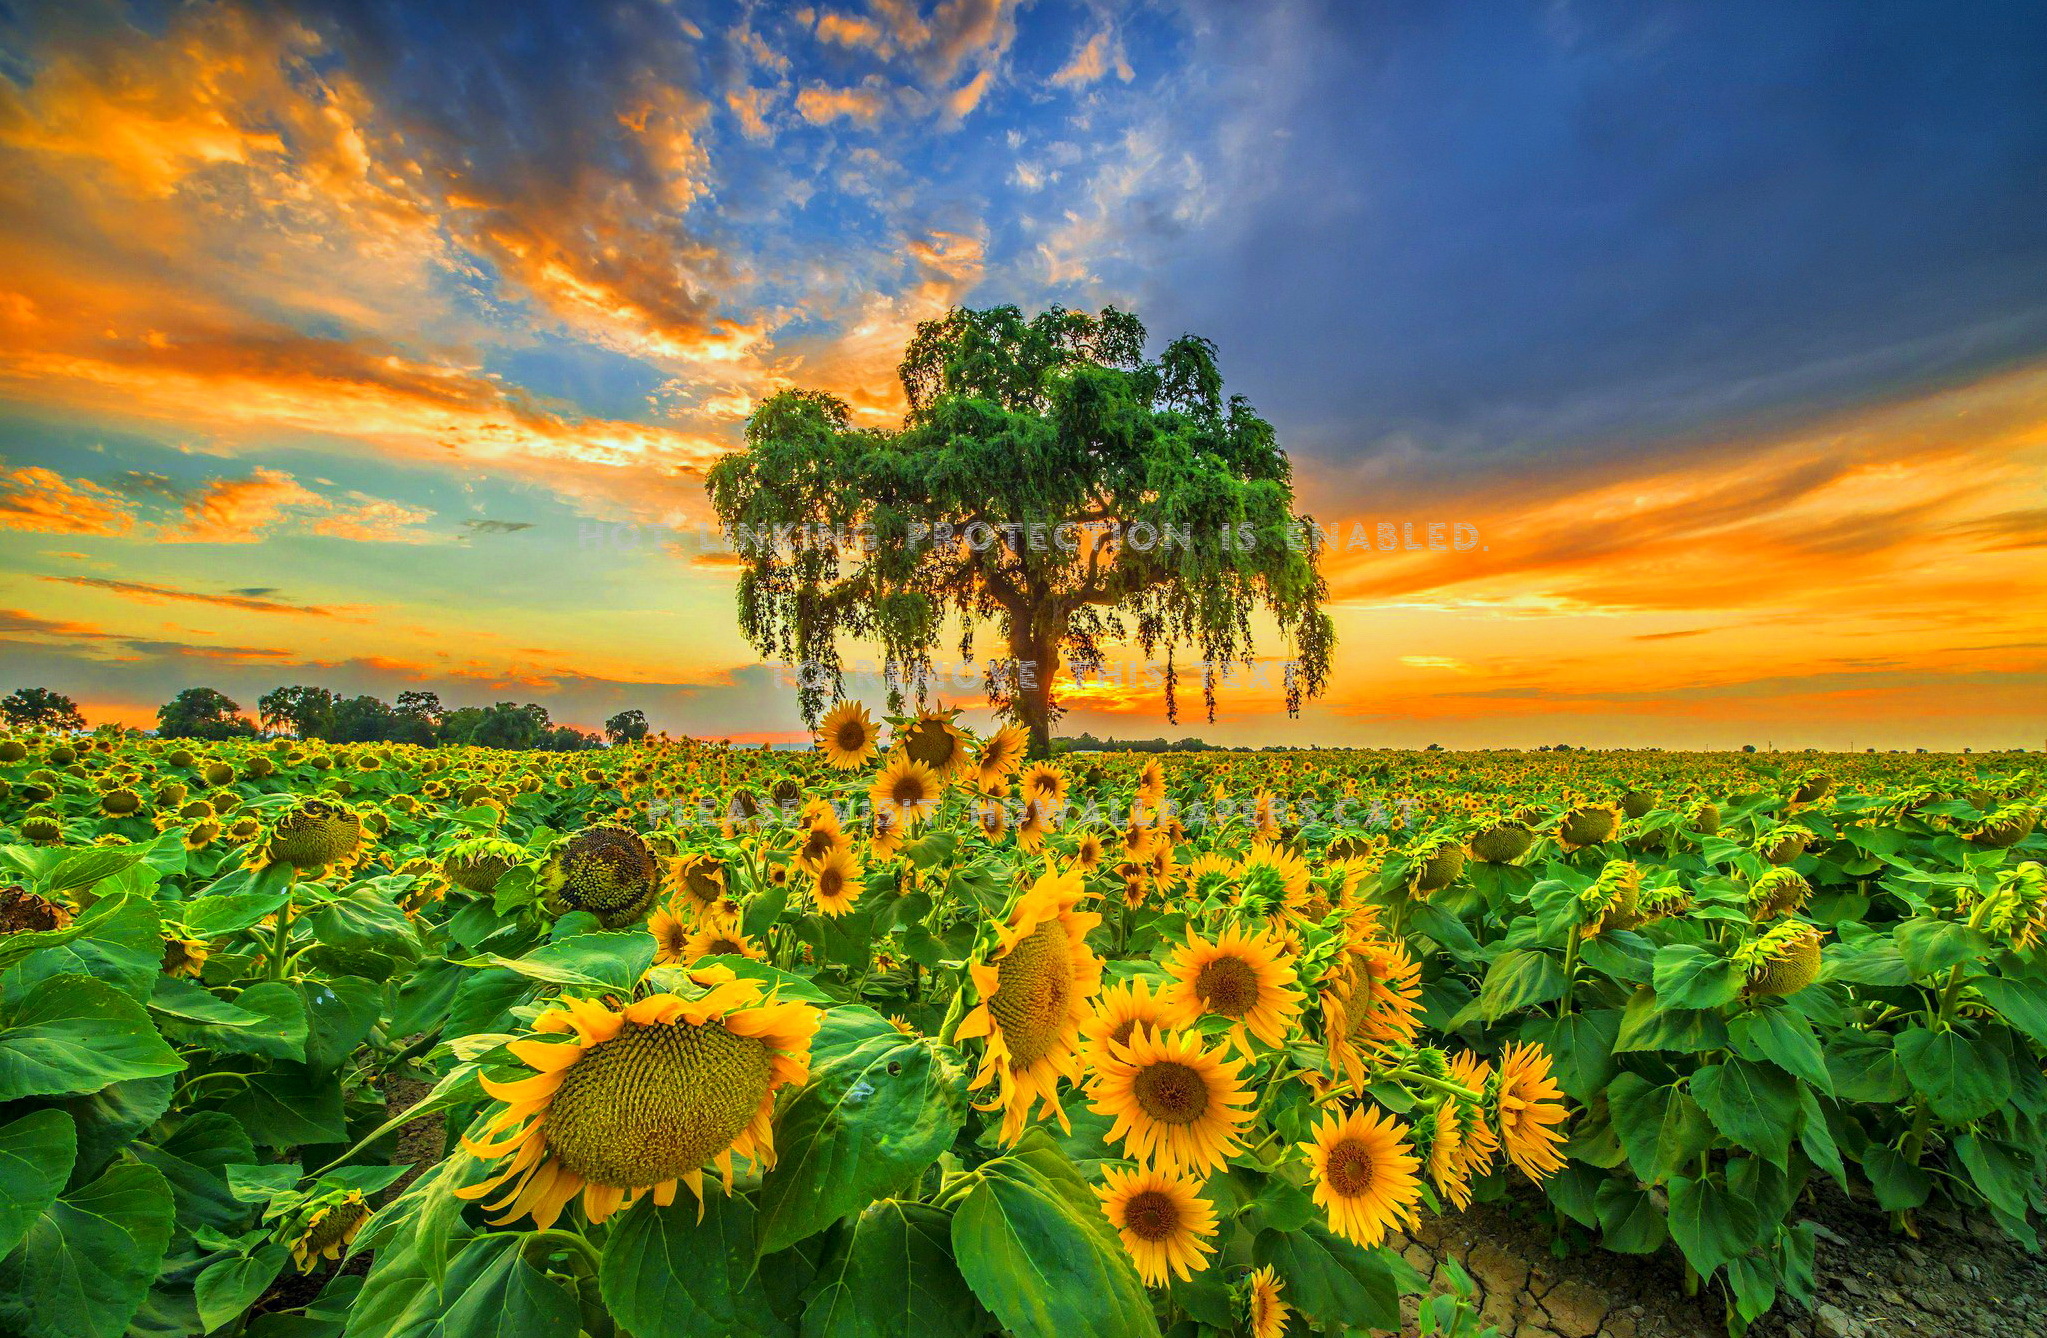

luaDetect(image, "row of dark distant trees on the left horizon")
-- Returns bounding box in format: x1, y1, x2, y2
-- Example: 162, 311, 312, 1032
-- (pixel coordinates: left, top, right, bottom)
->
0, 685, 647, 753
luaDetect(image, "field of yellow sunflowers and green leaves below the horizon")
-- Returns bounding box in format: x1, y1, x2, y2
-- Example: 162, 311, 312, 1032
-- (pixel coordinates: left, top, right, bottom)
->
0, 724, 2047, 1338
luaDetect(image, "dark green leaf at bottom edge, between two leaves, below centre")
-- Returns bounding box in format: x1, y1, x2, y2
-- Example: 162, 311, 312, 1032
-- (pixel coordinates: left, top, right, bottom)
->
802, 1199, 987, 1338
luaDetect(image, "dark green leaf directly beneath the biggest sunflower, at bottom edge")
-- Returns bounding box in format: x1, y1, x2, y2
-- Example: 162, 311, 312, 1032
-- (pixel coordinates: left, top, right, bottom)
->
598, 1191, 790, 1338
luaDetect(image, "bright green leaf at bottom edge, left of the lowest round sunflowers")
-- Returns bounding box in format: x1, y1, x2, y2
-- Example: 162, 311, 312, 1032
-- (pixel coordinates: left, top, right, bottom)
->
952, 1146, 1159, 1338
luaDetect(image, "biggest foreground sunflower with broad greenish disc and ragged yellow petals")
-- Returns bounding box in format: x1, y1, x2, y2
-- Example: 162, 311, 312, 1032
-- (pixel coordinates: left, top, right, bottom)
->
456, 968, 821, 1230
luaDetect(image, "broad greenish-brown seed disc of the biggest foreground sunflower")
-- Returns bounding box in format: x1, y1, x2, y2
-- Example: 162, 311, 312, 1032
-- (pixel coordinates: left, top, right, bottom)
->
545, 1021, 770, 1189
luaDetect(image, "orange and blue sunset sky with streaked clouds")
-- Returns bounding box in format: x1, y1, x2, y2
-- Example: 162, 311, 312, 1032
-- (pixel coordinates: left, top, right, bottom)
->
0, 0, 2047, 749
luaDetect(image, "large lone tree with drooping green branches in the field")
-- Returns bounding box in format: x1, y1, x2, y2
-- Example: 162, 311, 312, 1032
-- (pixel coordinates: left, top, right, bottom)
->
708, 307, 1335, 755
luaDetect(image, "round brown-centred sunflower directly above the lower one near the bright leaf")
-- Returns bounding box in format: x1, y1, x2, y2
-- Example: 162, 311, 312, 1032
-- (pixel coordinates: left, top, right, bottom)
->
1087, 1027, 1257, 1174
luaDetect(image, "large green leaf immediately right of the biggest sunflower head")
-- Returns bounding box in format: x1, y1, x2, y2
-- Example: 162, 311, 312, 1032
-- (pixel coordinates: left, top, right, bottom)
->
759, 1029, 966, 1254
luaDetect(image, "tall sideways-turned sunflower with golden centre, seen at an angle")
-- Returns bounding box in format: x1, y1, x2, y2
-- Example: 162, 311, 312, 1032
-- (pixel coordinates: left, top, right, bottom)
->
956, 874, 1101, 1144
